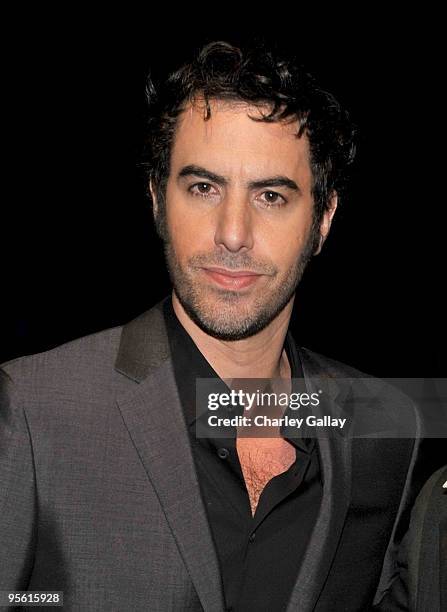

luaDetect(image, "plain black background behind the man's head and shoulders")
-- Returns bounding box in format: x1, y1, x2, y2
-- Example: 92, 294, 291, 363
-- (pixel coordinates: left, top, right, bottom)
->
0, 14, 446, 377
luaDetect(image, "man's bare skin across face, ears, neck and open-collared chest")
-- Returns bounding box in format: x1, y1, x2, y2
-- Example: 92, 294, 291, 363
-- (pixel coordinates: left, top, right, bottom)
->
151, 100, 337, 514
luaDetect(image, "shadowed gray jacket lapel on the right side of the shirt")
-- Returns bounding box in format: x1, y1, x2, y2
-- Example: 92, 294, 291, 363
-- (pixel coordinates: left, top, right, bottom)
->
287, 350, 351, 612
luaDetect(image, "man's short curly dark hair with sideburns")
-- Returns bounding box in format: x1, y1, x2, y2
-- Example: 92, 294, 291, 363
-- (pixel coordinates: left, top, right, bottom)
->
142, 41, 355, 232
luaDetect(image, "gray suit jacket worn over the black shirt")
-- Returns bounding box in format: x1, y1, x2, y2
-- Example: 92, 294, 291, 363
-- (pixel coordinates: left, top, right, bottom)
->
0, 296, 438, 612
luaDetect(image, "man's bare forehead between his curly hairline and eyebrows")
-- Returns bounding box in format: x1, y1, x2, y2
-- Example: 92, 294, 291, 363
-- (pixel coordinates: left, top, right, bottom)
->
171, 100, 310, 182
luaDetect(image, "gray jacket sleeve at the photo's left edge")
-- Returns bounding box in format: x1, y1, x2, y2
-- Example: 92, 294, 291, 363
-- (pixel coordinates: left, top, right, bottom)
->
0, 368, 36, 590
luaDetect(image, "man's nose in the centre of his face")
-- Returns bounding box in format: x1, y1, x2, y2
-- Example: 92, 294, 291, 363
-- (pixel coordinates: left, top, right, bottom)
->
214, 189, 253, 253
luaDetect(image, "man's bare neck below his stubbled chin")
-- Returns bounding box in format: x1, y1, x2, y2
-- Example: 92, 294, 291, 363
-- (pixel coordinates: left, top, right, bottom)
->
172, 292, 294, 379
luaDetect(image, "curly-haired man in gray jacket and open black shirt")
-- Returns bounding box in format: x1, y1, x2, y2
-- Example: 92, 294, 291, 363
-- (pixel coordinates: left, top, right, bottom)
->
0, 43, 440, 611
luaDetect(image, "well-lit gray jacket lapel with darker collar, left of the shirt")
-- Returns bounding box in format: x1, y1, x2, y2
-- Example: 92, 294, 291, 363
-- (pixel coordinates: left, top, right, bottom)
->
116, 305, 224, 611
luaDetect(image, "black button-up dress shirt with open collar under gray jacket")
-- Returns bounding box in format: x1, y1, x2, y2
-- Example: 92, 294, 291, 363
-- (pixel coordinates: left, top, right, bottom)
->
164, 298, 322, 612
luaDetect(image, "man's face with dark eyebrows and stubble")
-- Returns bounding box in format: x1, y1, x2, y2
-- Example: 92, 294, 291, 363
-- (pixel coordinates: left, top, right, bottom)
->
155, 101, 333, 340
